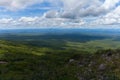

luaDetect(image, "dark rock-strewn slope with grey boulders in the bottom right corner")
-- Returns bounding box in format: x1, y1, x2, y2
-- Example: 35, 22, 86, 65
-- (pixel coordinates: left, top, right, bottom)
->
75, 50, 120, 80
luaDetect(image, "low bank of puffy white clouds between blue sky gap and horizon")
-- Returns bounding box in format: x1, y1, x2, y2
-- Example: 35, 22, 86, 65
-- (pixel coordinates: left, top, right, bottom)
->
0, 17, 85, 28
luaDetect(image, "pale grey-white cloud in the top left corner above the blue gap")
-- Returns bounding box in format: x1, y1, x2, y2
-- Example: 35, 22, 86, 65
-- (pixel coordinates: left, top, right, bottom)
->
0, 0, 43, 11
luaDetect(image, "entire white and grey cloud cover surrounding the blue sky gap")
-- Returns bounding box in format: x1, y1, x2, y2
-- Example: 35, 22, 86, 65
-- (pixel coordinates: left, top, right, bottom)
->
0, 0, 120, 27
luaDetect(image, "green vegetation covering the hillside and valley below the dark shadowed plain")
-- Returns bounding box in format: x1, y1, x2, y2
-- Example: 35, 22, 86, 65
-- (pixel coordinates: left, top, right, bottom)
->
0, 40, 120, 80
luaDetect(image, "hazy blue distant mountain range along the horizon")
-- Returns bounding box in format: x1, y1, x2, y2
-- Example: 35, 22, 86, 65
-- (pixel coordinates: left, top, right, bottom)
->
0, 29, 120, 35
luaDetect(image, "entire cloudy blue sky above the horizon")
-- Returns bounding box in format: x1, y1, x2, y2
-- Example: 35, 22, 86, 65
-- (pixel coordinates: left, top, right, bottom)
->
0, 0, 120, 29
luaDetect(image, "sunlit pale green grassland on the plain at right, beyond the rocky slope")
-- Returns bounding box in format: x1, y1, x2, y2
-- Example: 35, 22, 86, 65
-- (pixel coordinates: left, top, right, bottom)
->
66, 39, 120, 52
